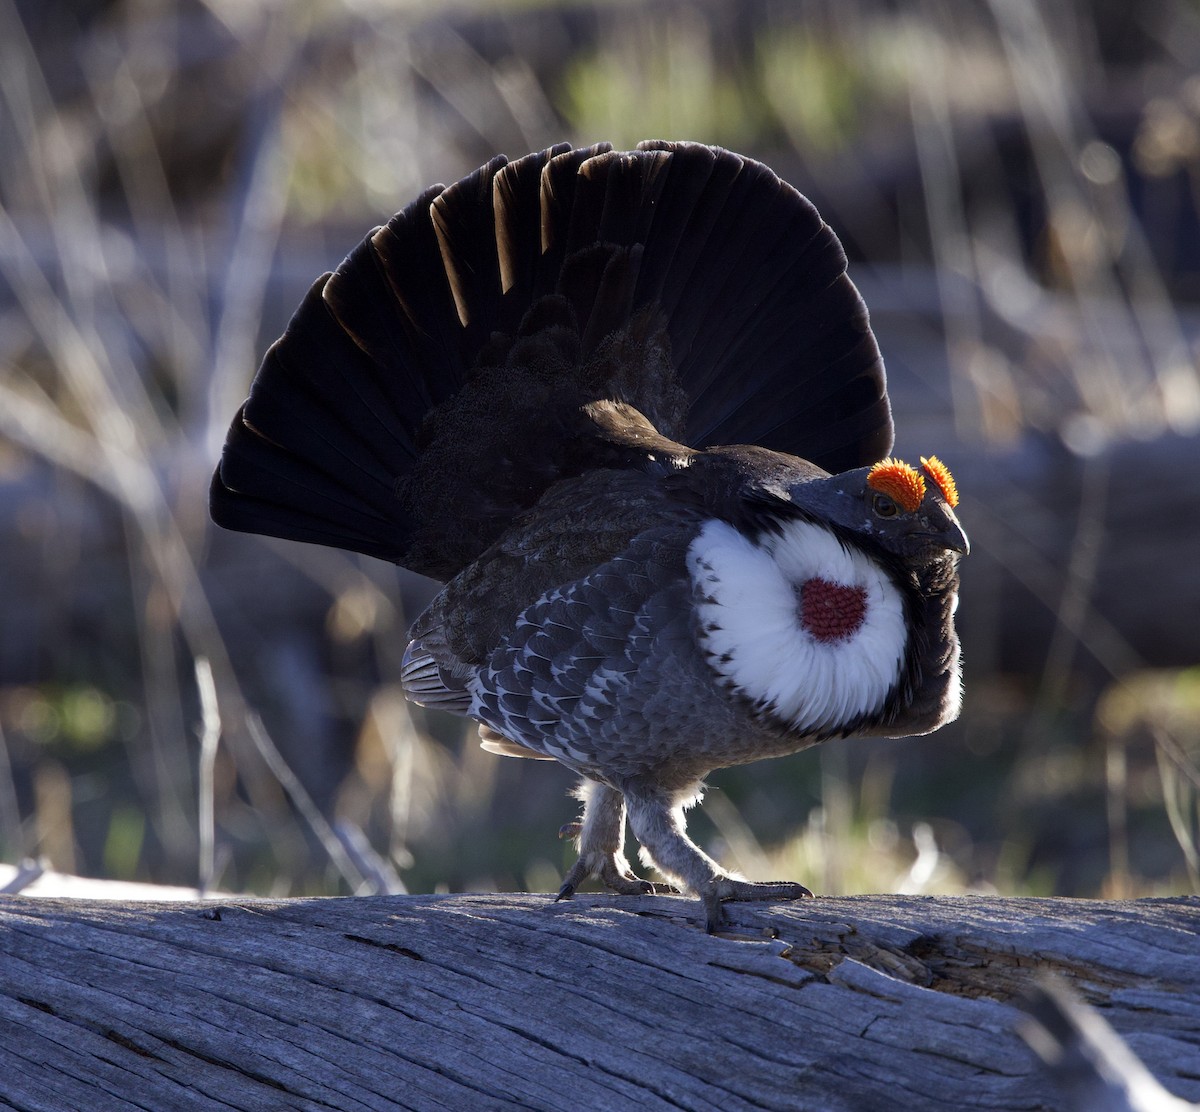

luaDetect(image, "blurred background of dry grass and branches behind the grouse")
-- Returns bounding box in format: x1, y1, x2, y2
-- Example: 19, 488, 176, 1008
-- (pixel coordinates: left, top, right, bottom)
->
0, 0, 1200, 895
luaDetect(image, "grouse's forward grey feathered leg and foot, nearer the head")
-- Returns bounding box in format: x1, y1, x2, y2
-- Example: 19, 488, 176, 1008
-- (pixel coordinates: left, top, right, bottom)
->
624, 789, 812, 934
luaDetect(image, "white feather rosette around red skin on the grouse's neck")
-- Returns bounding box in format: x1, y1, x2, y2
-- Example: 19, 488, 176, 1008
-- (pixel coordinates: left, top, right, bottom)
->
688, 521, 907, 733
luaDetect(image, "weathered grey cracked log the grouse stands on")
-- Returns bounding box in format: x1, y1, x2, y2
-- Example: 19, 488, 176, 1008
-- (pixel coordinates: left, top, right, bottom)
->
0, 895, 1200, 1112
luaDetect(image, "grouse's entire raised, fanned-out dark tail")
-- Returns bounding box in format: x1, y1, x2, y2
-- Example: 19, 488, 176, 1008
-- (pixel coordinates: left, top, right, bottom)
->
211, 143, 892, 575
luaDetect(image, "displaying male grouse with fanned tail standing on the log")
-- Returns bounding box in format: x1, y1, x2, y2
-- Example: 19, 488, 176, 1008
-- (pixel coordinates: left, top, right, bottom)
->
211, 142, 967, 928
